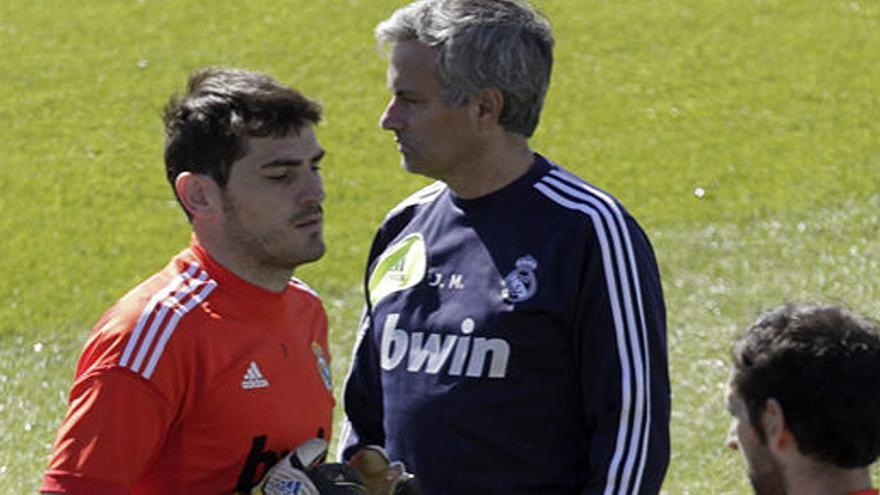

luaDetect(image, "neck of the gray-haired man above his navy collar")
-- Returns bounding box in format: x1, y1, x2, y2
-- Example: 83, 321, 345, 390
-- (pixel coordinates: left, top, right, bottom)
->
443, 133, 534, 199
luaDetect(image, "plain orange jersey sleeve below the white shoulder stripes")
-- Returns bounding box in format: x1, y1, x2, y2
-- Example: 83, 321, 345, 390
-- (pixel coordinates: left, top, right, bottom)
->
40, 367, 172, 495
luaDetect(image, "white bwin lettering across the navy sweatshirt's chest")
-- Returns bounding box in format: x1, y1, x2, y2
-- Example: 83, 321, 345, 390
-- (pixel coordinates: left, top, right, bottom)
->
381, 313, 510, 378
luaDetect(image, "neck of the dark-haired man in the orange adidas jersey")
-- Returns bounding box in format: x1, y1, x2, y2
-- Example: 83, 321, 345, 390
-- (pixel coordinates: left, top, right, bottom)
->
196, 229, 293, 292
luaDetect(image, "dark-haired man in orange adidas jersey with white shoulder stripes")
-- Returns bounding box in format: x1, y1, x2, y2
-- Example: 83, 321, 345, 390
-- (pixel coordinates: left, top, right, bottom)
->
41, 69, 334, 495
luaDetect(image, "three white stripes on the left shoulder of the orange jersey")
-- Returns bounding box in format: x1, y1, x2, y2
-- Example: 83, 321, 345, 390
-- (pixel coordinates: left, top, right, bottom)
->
119, 263, 217, 379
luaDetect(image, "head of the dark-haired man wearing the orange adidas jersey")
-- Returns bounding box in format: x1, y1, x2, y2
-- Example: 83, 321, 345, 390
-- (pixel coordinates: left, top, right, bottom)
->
164, 68, 324, 281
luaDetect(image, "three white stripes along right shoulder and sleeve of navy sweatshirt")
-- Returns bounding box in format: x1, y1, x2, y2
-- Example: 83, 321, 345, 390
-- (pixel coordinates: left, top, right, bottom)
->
534, 168, 651, 495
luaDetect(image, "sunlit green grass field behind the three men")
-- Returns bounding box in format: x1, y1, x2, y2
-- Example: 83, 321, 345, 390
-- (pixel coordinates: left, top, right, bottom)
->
0, 0, 880, 494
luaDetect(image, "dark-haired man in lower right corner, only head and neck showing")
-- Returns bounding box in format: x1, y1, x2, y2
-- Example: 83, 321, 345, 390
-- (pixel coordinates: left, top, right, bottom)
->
727, 304, 880, 495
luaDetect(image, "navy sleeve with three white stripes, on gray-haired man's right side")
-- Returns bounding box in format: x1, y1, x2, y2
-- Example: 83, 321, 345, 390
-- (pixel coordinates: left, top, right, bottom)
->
575, 213, 670, 495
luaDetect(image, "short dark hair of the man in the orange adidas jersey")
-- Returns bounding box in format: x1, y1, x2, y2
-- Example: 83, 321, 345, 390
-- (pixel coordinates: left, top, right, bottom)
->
163, 67, 321, 215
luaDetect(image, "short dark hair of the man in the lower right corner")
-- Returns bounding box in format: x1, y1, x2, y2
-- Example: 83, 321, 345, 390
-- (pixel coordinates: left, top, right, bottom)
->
731, 304, 880, 468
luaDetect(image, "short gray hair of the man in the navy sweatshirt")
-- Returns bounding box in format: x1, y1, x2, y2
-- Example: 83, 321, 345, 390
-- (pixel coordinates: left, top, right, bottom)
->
376, 0, 553, 137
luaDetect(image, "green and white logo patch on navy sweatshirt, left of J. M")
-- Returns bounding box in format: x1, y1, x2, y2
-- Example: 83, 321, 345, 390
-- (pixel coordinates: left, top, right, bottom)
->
367, 233, 428, 304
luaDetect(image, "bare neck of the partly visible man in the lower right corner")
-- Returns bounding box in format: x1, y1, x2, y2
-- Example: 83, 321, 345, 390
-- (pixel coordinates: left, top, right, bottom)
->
785, 461, 871, 495
